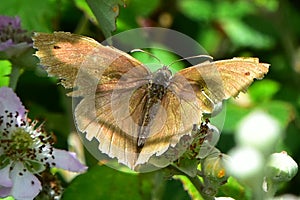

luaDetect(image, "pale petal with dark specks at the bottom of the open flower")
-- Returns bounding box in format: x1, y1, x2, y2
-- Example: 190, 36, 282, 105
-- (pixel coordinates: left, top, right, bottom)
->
11, 162, 42, 200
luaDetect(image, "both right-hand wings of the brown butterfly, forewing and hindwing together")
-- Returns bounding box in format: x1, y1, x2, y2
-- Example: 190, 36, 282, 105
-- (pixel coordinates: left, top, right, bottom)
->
137, 58, 269, 168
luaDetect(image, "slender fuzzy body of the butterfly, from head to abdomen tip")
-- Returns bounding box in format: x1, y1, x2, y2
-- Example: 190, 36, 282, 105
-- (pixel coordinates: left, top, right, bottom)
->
138, 66, 172, 148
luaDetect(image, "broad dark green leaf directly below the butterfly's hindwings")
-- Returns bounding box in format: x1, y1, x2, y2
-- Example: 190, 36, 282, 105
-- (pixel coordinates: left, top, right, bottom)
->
62, 165, 150, 200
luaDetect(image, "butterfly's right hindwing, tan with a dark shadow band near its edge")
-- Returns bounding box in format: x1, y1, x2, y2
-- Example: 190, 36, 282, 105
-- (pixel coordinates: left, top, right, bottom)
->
136, 90, 202, 165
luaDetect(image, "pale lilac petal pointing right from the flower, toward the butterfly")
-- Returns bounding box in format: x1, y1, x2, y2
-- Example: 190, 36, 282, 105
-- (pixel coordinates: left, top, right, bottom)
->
47, 149, 87, 172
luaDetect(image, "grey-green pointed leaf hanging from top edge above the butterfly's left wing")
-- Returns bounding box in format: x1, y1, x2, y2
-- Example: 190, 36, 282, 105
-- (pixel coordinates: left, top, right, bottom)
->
86, 0, 124, 38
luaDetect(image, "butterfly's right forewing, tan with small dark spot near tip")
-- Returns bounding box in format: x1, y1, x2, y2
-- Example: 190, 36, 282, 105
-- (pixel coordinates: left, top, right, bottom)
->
171, 58, 269, 113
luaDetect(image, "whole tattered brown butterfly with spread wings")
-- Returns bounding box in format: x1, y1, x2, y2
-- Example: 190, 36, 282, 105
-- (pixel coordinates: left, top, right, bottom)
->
33, 32, 269, 169
